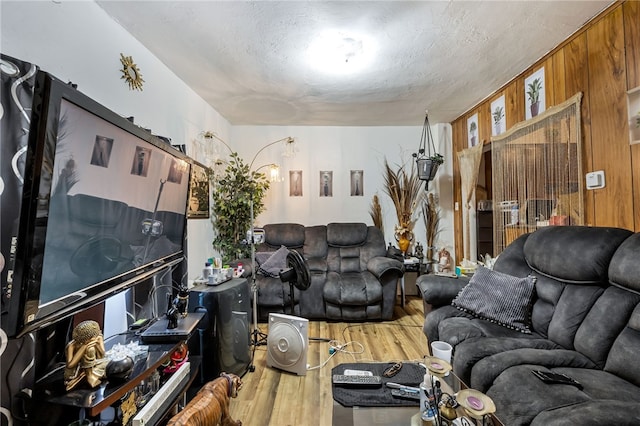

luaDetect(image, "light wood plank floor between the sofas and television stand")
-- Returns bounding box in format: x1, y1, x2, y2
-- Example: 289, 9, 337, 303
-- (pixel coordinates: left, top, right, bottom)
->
231, 296, 428, 426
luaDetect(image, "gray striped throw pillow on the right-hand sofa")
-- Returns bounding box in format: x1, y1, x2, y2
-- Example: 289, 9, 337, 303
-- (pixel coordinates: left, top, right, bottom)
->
451, 266, 536, 333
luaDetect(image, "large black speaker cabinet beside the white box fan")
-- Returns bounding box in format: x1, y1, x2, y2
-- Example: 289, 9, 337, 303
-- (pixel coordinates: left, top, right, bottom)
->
188, 278, 251, 383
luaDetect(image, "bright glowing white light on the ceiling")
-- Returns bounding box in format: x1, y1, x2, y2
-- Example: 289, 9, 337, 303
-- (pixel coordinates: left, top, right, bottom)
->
307, 30, 375, 74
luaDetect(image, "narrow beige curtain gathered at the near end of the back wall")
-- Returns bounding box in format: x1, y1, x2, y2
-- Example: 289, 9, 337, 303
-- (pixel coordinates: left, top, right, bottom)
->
457, 143, 484, 260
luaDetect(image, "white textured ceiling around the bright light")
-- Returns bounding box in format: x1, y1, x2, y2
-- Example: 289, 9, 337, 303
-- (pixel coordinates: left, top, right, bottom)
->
97, 0, 611, 126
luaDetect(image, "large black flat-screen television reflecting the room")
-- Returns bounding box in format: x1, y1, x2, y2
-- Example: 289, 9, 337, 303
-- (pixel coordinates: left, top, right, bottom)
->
2, 72, 191, 336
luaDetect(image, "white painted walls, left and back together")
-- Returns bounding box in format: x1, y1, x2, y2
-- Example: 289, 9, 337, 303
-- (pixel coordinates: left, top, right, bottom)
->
0, 1, 455, 279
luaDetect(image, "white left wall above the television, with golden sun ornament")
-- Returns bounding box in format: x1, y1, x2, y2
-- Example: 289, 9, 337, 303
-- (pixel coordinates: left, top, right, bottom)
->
0, 1, 225, 282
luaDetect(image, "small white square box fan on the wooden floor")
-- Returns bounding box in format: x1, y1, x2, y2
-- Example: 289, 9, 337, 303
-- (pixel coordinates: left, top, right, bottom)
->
267, 313, 309, 376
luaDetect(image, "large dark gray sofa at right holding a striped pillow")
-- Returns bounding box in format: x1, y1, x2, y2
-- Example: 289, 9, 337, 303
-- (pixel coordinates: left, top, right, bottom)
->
418, 226, 640, 426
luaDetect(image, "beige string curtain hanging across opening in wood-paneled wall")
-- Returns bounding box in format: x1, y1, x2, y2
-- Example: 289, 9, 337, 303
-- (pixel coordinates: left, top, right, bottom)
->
491, 93, 584, 255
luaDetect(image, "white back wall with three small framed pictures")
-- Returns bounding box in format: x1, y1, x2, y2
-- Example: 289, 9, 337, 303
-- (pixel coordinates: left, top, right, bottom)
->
231, 125, 454, 260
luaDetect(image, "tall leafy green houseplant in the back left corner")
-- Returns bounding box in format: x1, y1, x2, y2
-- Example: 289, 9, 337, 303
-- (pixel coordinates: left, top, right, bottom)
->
211, 152, 269, 263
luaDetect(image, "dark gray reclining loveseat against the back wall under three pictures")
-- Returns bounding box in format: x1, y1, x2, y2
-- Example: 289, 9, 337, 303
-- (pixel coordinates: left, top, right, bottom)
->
242, 223, 404, 321
